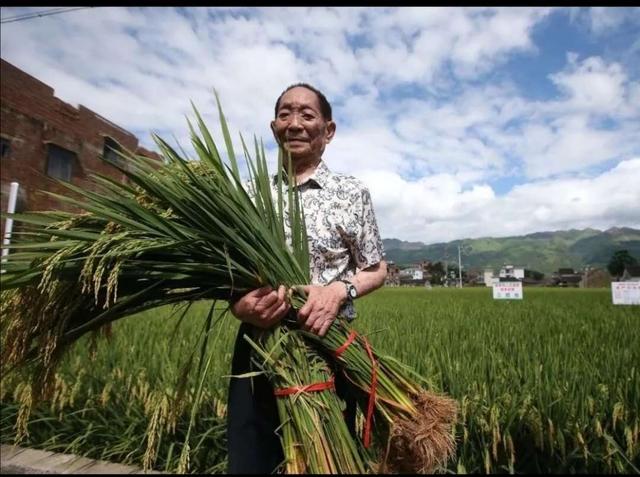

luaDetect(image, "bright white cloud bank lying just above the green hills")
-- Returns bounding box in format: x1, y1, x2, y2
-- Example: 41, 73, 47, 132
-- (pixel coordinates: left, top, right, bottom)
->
362, 158, 640, 243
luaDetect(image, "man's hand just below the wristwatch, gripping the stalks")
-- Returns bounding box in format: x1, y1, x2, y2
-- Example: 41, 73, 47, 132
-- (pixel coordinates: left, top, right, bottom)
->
298, 282, 347, 336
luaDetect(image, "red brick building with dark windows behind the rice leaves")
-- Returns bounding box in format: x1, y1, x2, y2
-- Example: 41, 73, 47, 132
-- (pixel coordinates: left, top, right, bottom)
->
0, 59, 161, 236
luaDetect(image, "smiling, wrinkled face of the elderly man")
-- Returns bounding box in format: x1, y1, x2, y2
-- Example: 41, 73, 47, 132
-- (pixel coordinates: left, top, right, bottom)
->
271, 87, 336, 161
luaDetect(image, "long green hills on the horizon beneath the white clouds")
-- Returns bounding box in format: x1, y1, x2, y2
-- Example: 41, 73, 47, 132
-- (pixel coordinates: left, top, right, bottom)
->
383, 227, 640, 274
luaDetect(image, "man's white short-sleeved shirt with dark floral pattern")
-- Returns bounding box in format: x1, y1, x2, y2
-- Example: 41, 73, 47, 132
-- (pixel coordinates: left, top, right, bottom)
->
272, 161, 384, 319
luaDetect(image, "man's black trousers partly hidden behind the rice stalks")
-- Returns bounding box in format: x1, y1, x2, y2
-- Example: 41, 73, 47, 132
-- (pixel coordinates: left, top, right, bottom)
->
227, 323, 356, 474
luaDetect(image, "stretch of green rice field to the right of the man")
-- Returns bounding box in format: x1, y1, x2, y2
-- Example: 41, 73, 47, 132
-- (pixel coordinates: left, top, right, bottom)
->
360, 288, 640, 473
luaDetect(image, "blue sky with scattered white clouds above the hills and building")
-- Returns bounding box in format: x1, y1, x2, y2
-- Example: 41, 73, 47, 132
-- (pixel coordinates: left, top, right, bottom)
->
0, 7, 640, 243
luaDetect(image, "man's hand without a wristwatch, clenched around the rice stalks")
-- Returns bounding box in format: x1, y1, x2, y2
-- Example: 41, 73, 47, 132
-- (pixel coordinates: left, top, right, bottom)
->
231, 285, 291, 328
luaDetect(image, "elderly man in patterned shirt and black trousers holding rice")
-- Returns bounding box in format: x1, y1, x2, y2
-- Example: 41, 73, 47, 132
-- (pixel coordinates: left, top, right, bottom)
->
227, 83, 387, 473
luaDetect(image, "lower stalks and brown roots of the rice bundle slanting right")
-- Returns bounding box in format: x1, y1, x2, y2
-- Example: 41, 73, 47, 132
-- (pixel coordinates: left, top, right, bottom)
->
301, 320, 458, 474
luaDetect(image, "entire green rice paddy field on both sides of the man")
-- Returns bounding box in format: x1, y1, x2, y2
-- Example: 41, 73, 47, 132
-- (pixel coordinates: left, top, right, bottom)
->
0, 288, 640, 474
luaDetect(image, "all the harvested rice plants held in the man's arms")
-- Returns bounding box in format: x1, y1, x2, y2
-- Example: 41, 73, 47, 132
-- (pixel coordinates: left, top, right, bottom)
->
0, 94, 455, 473
